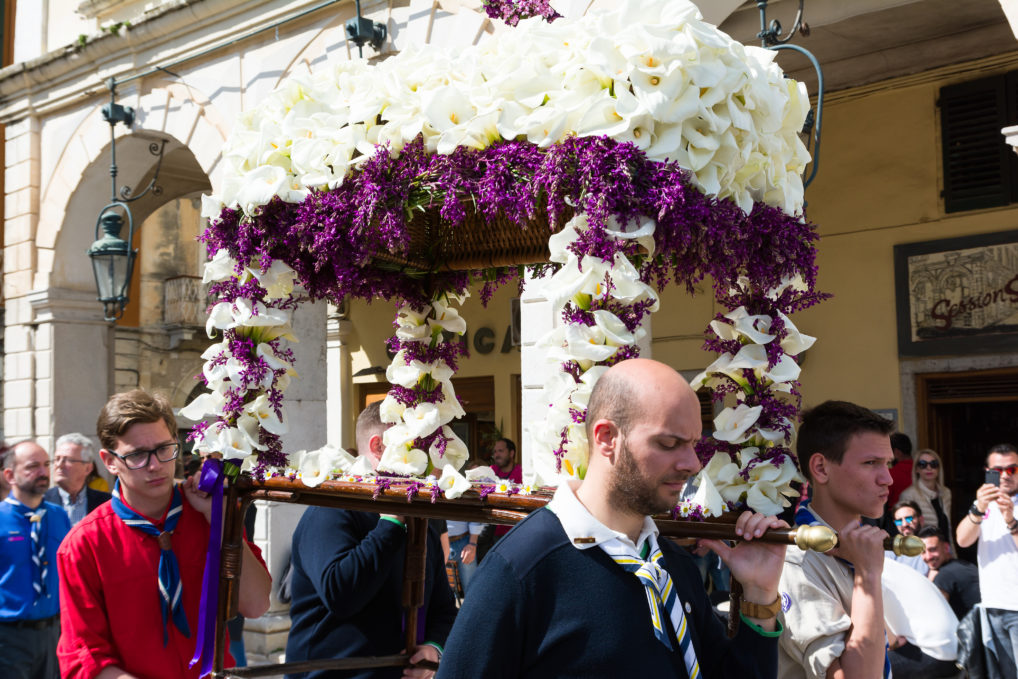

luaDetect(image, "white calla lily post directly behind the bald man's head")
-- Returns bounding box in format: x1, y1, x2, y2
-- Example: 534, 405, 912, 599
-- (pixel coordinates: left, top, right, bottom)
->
523, 214, 658, 486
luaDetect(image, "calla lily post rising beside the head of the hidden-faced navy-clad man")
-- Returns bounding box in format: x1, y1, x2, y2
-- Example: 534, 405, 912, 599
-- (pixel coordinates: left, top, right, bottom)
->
378, 293, 469, 497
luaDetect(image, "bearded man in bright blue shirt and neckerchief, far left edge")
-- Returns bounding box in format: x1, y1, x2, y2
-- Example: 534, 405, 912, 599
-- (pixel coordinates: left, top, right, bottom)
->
0, 441, 70, 679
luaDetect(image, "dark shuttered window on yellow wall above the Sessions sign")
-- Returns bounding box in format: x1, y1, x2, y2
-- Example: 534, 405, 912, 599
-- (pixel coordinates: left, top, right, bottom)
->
940, 72, 1018, 212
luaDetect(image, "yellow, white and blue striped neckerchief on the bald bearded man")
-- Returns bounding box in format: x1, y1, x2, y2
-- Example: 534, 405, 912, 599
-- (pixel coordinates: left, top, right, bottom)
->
606, 545, 700, 679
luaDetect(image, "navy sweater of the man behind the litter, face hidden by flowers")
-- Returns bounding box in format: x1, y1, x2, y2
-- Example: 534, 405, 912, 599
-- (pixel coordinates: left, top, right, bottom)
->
286, 507, 456, 679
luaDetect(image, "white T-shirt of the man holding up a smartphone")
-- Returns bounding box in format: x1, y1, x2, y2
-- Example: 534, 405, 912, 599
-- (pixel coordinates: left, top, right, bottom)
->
978, 497, 1018, 611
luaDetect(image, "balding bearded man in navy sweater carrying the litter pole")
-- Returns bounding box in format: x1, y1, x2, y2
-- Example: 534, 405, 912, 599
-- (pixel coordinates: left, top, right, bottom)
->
438, 359, 785, 679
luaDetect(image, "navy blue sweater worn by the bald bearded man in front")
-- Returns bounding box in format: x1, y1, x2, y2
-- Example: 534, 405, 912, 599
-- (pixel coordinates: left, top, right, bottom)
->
438, 509, 778, 679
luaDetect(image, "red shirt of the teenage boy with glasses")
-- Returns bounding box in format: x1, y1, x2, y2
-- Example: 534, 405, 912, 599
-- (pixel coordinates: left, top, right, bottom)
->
57, 500, 265, 679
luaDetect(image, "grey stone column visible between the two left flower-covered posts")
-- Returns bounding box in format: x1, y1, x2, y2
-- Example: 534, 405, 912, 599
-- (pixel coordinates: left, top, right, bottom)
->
244, 302, 328, 663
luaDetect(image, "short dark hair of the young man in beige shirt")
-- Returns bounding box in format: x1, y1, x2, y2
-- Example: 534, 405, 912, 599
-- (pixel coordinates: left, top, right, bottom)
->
794, 403, 894, 480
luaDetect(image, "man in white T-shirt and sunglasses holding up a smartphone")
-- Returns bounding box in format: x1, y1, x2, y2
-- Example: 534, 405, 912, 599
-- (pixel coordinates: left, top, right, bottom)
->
956, 437, 1018, 679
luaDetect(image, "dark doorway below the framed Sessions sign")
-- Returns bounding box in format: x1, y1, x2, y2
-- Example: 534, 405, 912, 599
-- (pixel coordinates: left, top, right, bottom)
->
913, 367, 1018, 562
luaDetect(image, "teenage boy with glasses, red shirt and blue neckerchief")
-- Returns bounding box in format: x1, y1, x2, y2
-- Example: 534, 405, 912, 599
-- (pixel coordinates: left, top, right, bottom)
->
57, 390, 270, 679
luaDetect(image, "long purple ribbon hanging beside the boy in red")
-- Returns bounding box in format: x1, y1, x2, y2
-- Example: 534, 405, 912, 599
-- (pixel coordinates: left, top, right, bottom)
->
188, 457, 226, 677
